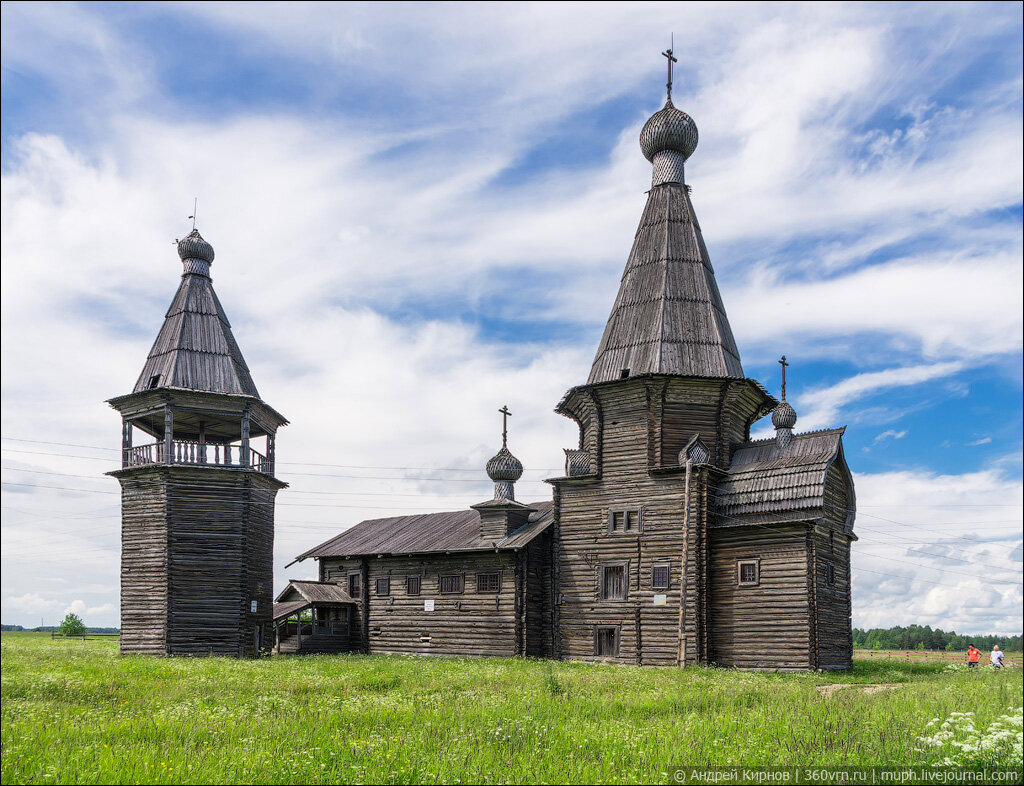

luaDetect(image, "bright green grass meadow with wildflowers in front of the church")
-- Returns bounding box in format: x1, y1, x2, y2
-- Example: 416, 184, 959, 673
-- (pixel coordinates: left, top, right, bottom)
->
2, 632, 1022, 784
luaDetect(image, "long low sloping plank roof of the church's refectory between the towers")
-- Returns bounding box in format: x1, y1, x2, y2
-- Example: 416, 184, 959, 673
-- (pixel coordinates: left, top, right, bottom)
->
295, 500, 554, 562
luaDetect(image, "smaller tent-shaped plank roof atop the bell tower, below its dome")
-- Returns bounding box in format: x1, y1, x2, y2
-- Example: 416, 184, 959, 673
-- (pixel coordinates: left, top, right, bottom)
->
133, 272, 259, 398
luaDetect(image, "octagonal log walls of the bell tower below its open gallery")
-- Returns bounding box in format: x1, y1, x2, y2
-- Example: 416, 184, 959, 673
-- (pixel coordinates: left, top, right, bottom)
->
119, 466, 280, 657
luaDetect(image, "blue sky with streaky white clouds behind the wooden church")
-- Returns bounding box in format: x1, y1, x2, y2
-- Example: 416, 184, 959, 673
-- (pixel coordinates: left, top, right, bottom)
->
0, 3, 1022, 631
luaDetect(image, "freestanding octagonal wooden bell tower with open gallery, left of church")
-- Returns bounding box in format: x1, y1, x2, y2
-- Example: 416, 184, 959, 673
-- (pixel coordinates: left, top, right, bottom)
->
108, 229, 288, 657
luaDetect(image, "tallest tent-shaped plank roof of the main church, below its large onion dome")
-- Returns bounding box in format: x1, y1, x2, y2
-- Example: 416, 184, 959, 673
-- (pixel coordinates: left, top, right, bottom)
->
589, 183, 743, 384
